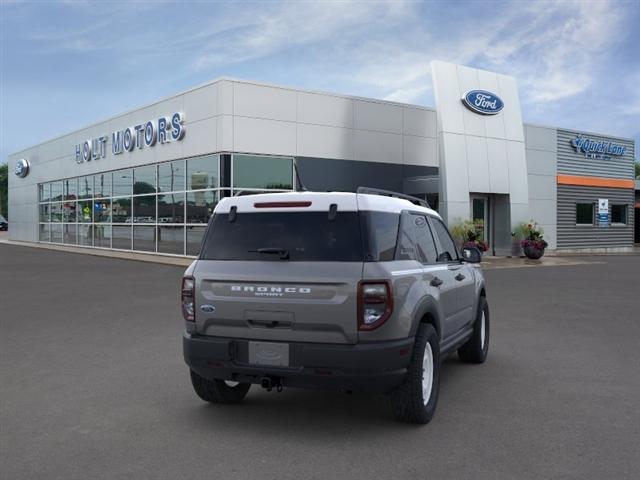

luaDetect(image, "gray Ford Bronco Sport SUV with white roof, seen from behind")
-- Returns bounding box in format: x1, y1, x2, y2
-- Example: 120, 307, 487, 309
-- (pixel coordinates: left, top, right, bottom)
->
181, 189, 489, 423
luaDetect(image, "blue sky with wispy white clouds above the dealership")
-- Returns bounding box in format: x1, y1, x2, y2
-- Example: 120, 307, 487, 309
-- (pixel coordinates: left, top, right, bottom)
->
0, 0, 640, 162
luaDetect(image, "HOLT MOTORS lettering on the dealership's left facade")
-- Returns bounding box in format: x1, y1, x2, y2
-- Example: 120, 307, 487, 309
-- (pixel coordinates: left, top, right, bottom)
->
76, 112, 185, 164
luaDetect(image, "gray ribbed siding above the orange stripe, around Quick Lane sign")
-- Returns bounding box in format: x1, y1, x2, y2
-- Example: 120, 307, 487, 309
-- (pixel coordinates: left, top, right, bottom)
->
558, 129, 635, 180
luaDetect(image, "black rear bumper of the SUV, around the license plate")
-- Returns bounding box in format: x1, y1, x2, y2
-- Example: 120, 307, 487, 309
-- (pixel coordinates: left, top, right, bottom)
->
182, 332, 414, 393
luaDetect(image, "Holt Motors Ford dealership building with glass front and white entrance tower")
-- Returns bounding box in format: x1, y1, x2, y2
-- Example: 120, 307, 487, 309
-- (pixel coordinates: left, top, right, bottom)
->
9, 62, 640, 256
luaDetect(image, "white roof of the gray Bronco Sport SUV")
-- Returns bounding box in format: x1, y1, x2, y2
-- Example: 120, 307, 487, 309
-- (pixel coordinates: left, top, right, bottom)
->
215, 192, 440, 218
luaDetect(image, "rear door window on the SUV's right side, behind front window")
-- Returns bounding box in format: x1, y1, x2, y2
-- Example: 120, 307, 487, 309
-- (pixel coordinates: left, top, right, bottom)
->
397, 213, 437, 263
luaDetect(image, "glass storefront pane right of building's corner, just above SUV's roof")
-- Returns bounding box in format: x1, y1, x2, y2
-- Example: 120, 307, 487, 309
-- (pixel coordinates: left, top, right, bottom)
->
232, 155, 293, 190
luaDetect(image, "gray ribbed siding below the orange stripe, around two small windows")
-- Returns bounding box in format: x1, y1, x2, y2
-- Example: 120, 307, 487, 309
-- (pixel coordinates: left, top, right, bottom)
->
558, 185, 635, 249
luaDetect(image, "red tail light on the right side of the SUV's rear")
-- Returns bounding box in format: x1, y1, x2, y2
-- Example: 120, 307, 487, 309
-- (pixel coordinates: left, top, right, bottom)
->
358, 280, 393, 331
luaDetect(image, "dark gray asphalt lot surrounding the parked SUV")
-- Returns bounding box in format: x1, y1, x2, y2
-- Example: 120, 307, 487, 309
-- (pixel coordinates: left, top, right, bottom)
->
0, 244, 640, 480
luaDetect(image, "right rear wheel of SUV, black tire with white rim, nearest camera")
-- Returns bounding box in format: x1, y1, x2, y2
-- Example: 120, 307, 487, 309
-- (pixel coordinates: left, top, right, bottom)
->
391, 323, 440, 424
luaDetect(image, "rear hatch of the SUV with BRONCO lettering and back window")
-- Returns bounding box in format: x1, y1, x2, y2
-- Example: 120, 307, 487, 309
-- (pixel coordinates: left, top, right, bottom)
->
194, 196, 364, 343
